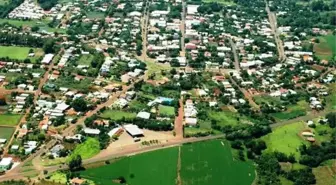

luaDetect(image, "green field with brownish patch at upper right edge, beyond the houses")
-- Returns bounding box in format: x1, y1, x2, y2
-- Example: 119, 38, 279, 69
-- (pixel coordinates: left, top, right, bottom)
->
314, 35, 336, 60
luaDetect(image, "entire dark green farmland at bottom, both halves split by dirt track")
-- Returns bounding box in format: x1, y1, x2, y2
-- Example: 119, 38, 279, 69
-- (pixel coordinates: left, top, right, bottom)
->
81, 140, 255, 185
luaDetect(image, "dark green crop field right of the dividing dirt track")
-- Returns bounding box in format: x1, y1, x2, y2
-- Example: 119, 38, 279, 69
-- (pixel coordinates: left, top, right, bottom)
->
181, 140, 255, 185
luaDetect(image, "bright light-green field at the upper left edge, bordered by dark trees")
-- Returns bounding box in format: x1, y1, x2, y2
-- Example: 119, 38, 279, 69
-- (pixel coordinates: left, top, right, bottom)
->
0, 46, 43, 61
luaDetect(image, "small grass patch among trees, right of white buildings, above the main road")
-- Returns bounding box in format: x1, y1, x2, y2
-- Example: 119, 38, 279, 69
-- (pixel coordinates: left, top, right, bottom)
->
208, 111, 238, 126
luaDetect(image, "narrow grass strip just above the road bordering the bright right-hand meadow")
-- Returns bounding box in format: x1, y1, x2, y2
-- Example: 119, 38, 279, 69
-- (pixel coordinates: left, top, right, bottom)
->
271, 100, 308, 121
